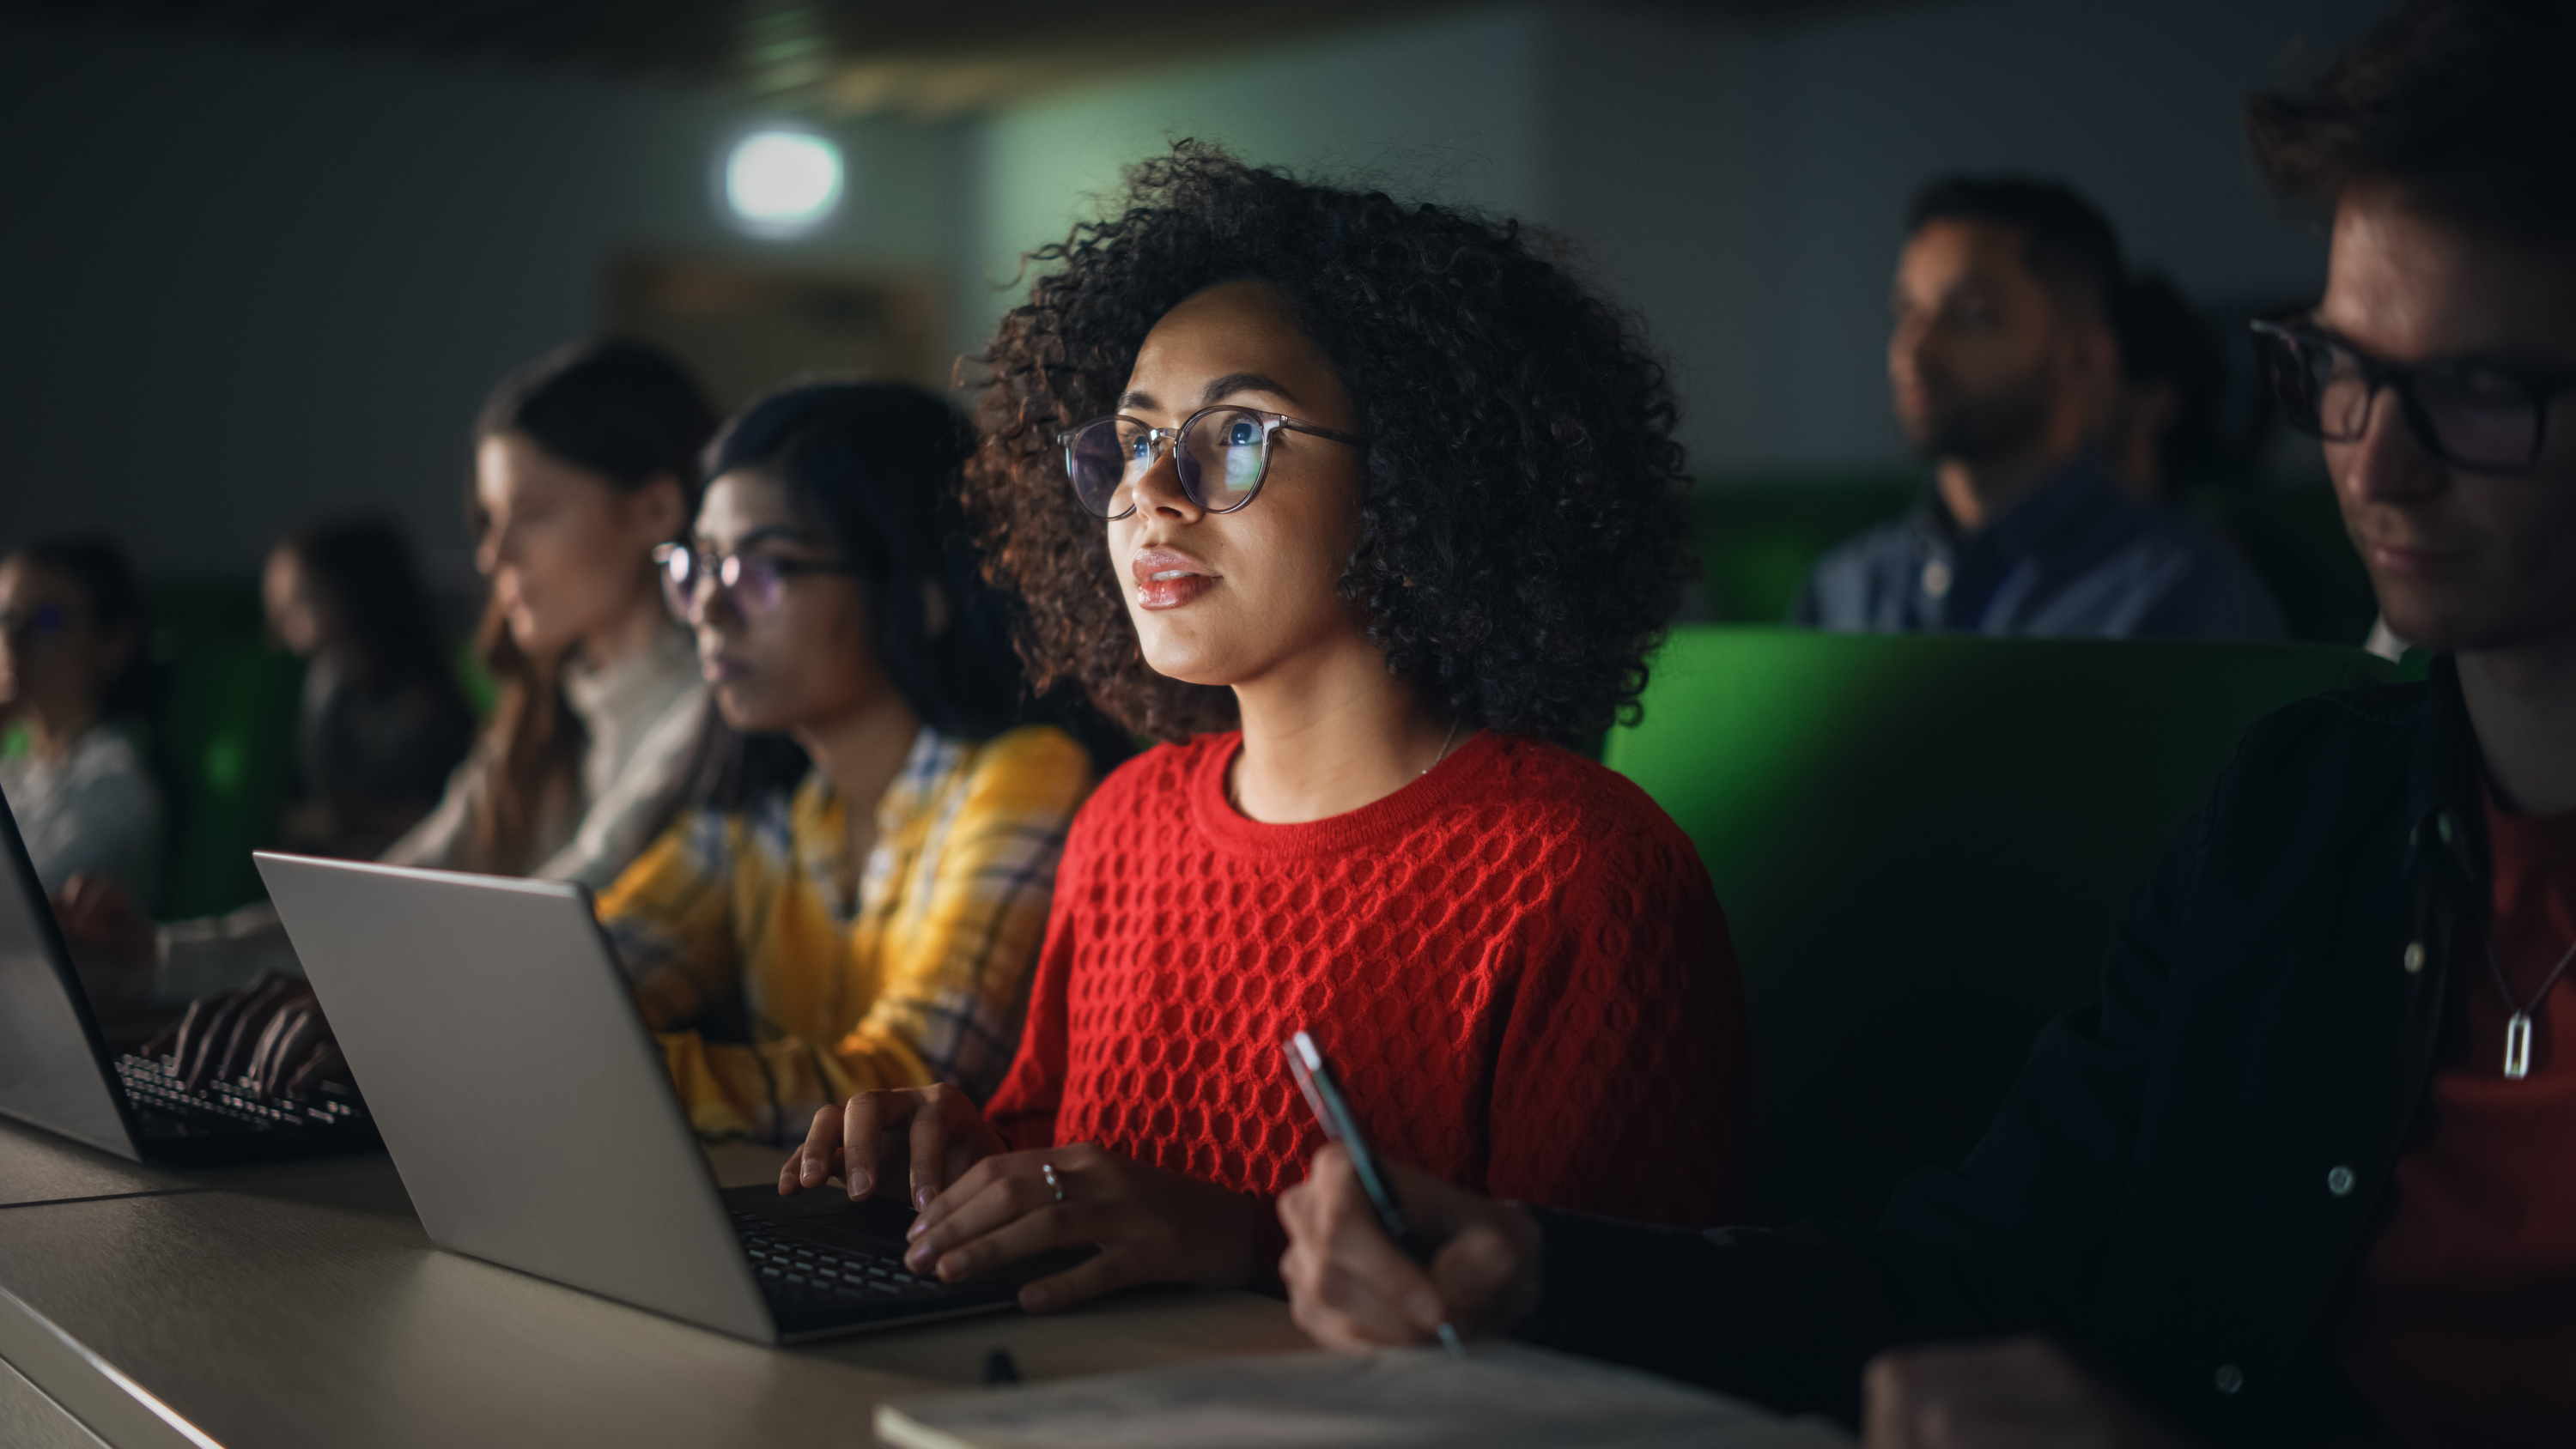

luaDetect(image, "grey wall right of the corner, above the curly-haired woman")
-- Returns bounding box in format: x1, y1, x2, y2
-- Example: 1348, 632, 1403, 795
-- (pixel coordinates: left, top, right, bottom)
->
974, 0, 2388, 474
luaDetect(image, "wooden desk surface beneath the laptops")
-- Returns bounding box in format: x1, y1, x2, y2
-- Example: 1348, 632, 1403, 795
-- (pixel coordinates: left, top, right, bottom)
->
0, 1148, 1306, 1449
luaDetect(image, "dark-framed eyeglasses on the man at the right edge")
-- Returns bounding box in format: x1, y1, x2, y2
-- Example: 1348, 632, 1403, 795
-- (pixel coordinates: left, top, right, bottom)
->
2272, 337, 2545, 469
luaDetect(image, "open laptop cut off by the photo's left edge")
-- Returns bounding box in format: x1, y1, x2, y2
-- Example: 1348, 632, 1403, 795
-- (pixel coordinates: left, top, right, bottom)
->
0, 803, 376, 1166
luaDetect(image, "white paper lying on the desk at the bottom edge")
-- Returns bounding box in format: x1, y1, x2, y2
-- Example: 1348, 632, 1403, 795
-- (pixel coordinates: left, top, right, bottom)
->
876, 1343, 1852, 1449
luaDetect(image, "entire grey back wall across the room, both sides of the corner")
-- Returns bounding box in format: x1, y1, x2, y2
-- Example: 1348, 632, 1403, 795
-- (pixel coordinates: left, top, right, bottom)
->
0, 0, 2385, 585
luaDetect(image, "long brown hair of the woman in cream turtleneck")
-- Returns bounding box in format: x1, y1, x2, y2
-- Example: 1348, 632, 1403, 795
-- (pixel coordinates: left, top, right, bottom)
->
466, 343, 716, 872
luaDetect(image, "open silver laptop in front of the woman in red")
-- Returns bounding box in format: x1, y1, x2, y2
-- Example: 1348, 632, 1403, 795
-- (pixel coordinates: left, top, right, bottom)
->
255, 852, 1074, 1343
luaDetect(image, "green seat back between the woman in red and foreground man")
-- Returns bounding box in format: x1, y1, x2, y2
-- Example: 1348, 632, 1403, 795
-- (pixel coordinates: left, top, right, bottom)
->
1605, 626, 2393, 1222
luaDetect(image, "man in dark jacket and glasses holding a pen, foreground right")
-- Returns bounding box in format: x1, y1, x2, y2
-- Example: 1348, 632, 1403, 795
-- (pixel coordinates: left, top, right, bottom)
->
1280, 0, 2576, 1446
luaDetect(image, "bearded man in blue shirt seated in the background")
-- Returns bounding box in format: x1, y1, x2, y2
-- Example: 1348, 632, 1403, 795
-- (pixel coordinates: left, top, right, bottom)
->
1790, 178, 2282, 639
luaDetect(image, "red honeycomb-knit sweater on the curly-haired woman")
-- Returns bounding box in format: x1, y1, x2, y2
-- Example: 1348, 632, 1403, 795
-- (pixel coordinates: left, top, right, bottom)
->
987, 733, 1747, 1228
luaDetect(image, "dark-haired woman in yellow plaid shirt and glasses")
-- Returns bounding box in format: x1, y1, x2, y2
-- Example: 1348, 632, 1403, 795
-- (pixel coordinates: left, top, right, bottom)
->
598, 384, 1095, 1143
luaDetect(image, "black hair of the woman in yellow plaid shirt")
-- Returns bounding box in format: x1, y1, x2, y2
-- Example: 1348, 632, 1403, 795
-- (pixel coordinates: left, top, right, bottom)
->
706, 381, 1028, 808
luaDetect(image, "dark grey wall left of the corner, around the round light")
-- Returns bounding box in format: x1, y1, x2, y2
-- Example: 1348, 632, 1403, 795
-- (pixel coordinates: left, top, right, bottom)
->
0, 23, 963, 587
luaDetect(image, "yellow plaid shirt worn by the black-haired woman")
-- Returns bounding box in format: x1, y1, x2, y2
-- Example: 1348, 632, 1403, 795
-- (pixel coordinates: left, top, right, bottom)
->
636, 725, 1092, 1143
